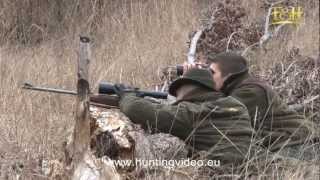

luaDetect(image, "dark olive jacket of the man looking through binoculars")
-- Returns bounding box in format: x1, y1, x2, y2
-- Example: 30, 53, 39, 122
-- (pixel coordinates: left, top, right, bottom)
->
223, 73, 313, 151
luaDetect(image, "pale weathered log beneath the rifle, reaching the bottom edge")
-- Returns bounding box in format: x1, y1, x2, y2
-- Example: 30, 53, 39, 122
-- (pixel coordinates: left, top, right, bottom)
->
73, 106, 188, 180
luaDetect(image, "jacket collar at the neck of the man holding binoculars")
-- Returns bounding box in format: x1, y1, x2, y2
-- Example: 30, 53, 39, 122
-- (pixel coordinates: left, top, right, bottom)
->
221, 69, 250, 95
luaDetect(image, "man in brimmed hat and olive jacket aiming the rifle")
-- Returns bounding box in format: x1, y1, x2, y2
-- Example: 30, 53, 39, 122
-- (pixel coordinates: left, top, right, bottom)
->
115, 68, 254, 165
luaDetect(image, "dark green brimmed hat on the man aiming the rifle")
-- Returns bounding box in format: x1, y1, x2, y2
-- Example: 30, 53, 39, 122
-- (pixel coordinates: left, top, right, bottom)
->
169, 68, 215, 96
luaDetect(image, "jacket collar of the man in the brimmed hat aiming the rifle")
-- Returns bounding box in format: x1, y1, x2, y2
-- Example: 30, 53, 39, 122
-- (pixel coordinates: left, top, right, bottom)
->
173, 91, 224, 105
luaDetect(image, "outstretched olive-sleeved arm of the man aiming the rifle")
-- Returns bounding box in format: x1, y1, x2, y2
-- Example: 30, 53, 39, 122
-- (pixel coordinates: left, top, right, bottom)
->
119, 95, 201, 139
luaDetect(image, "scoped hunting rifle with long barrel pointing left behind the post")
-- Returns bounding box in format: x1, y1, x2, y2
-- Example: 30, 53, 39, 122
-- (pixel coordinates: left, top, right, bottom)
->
22, 82, 168, 108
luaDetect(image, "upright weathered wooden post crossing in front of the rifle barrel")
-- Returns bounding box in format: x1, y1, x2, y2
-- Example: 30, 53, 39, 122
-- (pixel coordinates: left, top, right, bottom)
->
72, 37, 90, 168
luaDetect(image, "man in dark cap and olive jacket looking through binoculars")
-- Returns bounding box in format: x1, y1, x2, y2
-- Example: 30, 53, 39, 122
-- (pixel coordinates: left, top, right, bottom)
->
190, 52, 315, 154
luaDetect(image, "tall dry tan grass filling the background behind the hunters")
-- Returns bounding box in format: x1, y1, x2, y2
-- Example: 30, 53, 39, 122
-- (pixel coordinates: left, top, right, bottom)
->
0, 0, 319, 179
